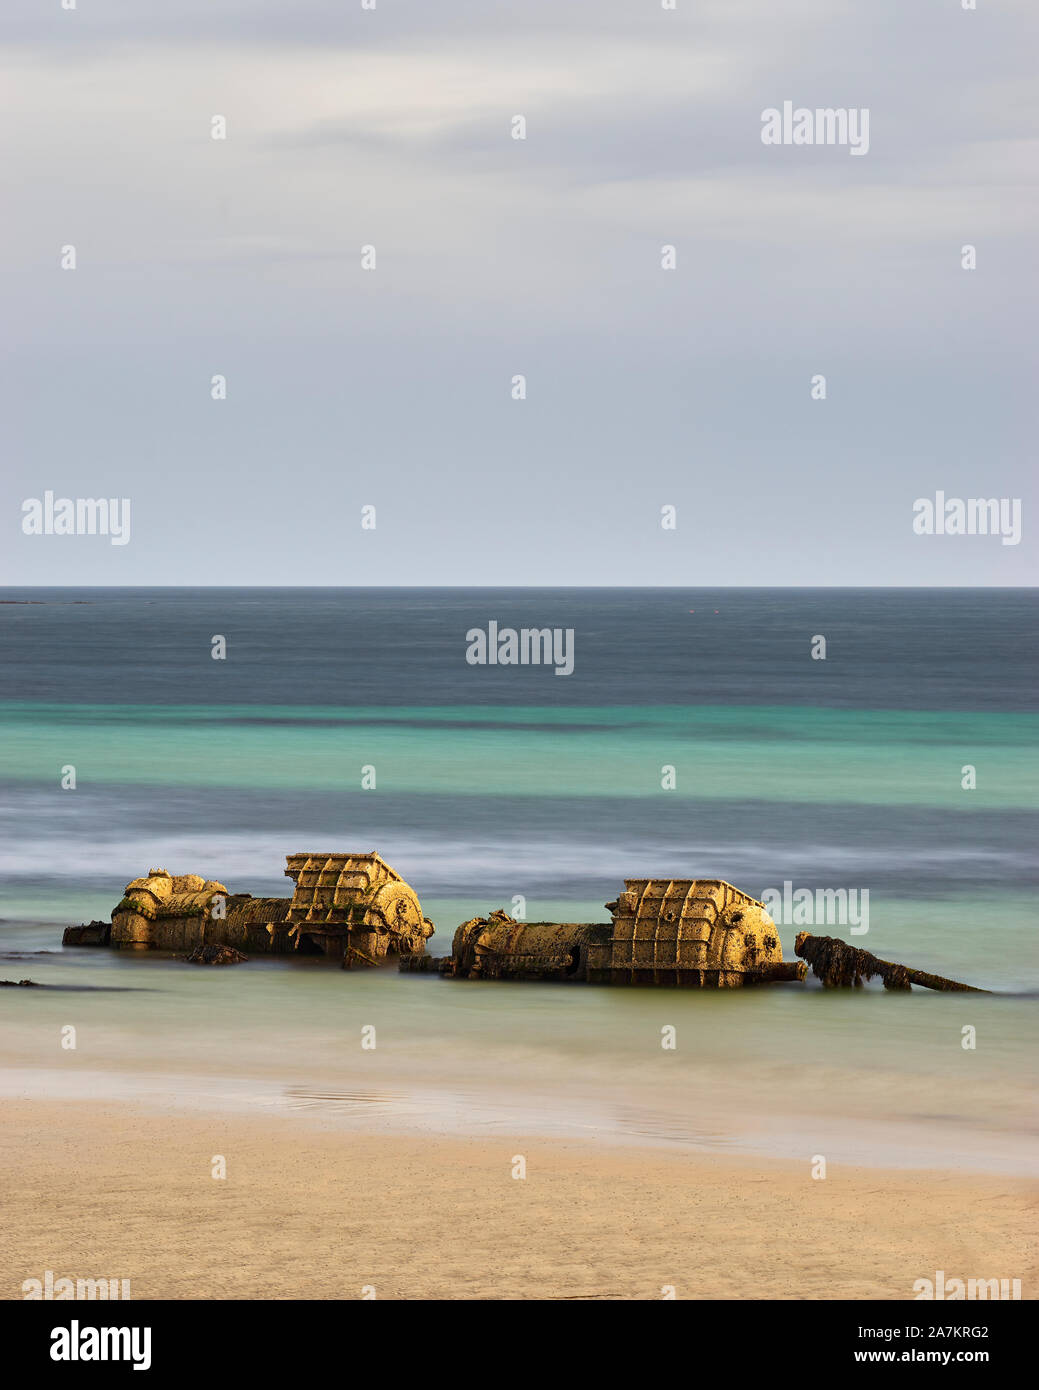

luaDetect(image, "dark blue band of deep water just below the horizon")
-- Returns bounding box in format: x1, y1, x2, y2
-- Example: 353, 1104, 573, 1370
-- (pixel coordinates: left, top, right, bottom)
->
0, 589, 1039, 712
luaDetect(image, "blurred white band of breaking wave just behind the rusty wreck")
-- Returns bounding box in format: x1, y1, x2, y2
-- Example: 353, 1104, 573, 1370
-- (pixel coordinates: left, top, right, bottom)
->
0, 826, 1031, 897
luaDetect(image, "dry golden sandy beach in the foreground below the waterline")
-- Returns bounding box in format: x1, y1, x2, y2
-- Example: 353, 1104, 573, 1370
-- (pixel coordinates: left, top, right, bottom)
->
0, 1101, 1039, 1300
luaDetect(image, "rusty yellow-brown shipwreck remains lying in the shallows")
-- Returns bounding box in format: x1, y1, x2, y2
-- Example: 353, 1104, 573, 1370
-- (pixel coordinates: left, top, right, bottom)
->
63, 851, 990, 990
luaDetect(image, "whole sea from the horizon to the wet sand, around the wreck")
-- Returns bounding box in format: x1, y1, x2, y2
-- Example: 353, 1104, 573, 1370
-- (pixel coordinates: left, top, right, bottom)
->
0, 588, 1039, 1173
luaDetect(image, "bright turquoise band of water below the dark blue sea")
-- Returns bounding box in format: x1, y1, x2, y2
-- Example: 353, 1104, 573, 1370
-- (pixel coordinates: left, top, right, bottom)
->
0, 703, 1039, 812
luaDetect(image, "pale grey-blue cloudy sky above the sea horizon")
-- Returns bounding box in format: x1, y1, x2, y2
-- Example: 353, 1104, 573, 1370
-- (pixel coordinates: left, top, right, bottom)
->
0, 0, 1039, 587
